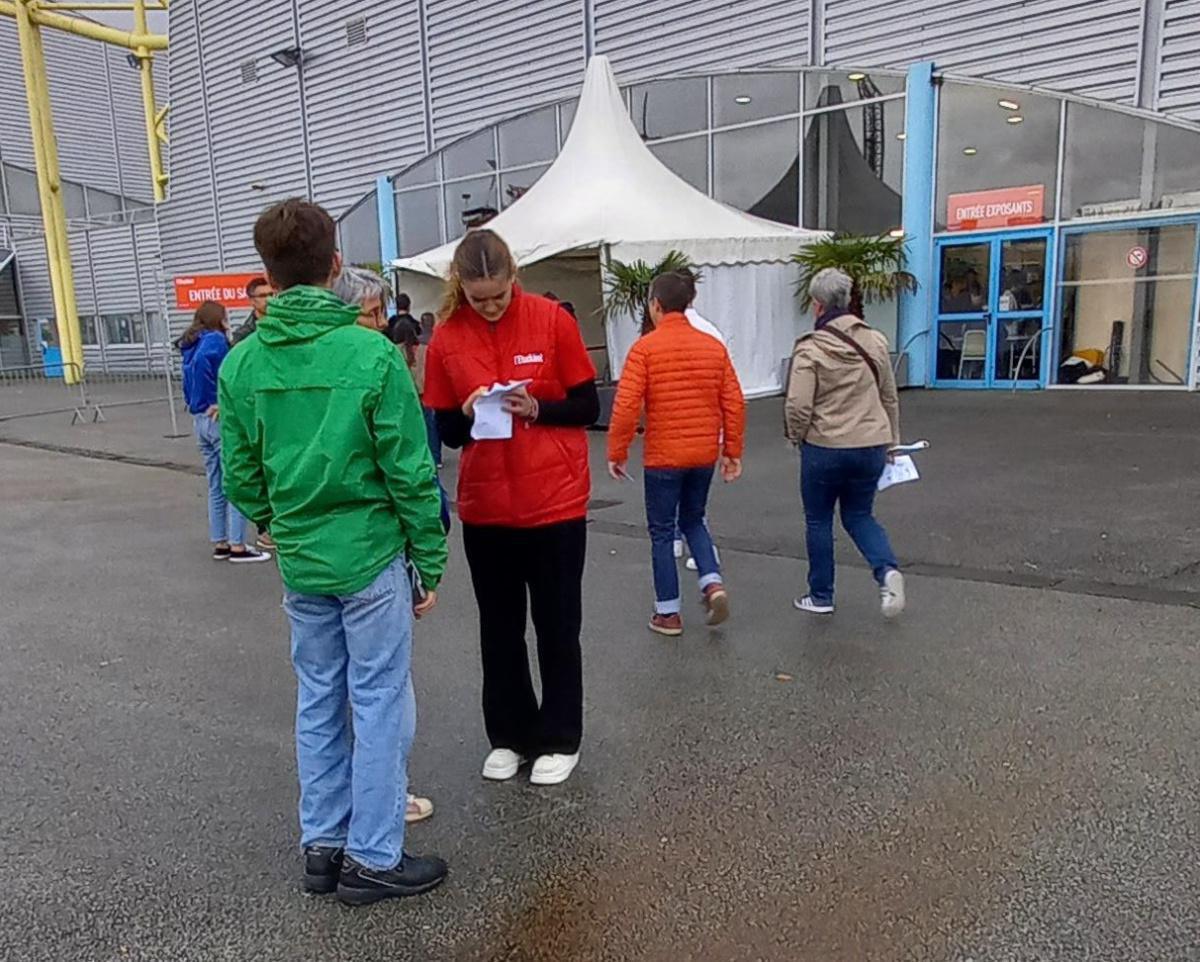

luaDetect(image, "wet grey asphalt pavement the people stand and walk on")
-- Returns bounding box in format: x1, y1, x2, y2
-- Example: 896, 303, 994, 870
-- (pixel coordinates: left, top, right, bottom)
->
0, 393, 1200, 962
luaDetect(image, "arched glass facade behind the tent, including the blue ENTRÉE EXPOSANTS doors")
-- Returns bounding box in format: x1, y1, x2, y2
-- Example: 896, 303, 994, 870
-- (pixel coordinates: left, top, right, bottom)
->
360, 68, 1200, 386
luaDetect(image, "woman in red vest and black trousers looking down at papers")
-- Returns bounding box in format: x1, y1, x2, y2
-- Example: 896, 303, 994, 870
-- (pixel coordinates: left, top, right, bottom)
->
424, 230, 600, 784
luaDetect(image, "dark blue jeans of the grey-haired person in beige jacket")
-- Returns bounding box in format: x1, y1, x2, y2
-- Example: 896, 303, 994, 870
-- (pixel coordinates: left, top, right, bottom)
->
800, 444, 900, 605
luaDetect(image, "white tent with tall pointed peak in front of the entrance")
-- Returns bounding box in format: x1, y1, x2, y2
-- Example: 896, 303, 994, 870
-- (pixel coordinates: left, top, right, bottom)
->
395, 56, 821, 396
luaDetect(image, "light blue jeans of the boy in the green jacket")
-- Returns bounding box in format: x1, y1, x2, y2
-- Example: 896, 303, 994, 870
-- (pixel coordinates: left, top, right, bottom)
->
283, 555, 416, 870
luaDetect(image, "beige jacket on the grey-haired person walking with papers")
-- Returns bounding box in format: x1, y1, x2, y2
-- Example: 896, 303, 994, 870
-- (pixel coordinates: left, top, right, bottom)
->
784, 314, 900, 447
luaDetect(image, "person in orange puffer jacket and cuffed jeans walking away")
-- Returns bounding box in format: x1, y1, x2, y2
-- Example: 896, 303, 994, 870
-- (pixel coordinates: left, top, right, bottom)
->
608, 272, 745, 637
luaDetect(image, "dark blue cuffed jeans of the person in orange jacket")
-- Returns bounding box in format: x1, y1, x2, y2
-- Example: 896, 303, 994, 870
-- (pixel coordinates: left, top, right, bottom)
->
646, 465, 721, 614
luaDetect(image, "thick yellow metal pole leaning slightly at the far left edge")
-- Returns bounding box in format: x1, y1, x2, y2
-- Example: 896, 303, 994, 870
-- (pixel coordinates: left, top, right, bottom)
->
14, 0, 83, 384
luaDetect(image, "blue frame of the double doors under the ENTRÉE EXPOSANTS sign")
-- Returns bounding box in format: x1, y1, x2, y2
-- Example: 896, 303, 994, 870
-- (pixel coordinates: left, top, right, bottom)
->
930, 227, 1058, 390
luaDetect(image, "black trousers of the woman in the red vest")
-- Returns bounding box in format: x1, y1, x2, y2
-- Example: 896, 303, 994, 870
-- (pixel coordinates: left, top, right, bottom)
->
462, 518, 587, 756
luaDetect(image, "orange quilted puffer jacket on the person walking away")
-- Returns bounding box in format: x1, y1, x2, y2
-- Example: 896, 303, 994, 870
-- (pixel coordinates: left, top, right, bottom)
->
608, 314, 745, 468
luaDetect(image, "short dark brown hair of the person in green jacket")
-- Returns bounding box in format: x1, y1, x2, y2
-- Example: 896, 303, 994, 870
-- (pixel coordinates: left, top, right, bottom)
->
254, 197, 337, 290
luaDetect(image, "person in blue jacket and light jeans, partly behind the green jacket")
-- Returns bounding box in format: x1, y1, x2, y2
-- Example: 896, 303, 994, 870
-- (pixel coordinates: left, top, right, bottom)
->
178, 301, 271, 564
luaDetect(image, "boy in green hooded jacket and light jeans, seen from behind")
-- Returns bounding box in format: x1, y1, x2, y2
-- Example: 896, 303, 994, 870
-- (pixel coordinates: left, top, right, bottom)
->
218, 199, 446, 904
